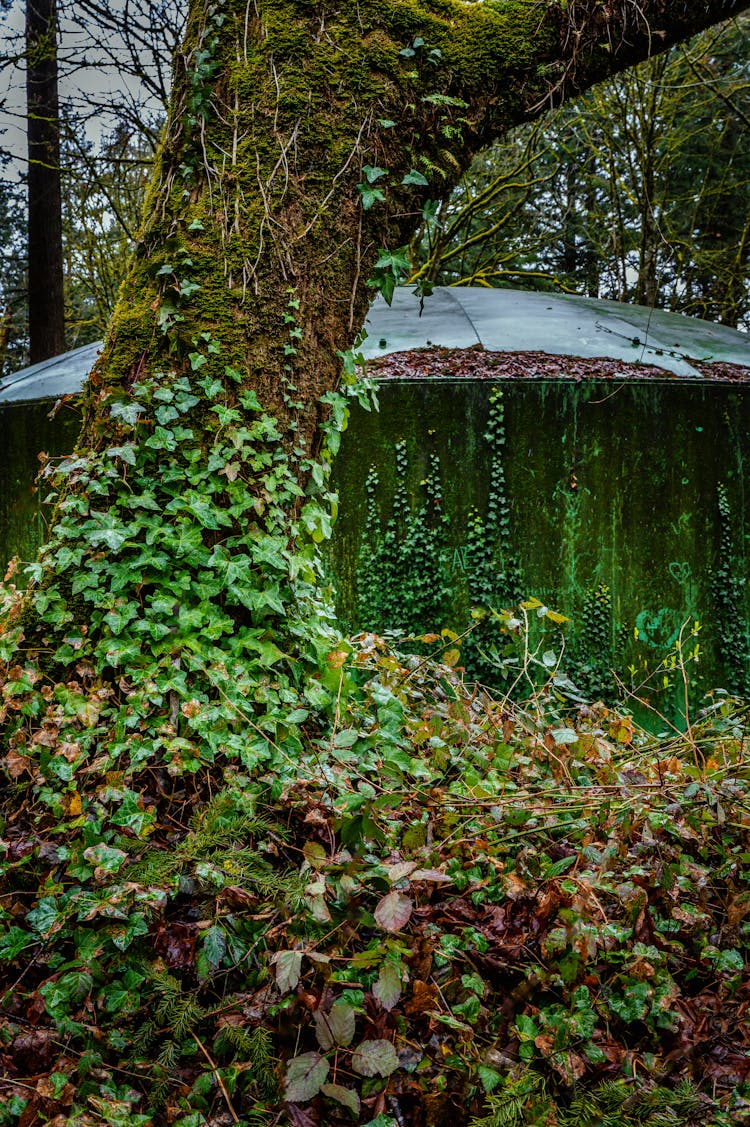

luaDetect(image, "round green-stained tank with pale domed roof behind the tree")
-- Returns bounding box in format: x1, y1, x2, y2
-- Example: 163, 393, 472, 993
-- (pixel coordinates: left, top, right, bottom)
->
0, 287, 750, 716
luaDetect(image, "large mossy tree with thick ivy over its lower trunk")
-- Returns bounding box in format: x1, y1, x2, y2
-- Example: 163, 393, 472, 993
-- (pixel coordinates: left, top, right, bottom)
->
0, 0, 748, 1122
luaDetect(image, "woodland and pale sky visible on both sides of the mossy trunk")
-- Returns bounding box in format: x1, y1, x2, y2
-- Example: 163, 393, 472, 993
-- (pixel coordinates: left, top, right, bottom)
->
0, 0, 750, 374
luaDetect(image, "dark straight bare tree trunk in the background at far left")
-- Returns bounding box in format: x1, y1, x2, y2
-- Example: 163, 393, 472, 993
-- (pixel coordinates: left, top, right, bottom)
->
26, 0, 65, 364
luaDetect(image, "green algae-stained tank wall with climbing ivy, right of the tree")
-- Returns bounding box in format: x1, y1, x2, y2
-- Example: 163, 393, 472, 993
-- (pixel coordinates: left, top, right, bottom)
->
333, 379, 750, 706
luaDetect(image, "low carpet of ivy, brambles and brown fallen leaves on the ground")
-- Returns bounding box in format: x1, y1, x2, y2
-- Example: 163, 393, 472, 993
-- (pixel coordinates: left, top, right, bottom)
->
0, 635, 750, 1127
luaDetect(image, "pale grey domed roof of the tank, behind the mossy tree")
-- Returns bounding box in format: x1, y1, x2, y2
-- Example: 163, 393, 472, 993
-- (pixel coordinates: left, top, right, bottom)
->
0, 286, 750, 406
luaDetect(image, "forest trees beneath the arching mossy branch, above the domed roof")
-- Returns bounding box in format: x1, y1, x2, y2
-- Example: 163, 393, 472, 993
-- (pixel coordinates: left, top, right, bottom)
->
413, 17, 750, 327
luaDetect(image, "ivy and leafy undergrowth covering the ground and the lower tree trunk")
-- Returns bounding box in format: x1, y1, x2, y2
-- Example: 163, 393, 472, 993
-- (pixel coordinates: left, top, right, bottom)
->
0, 344, 750, 1127
